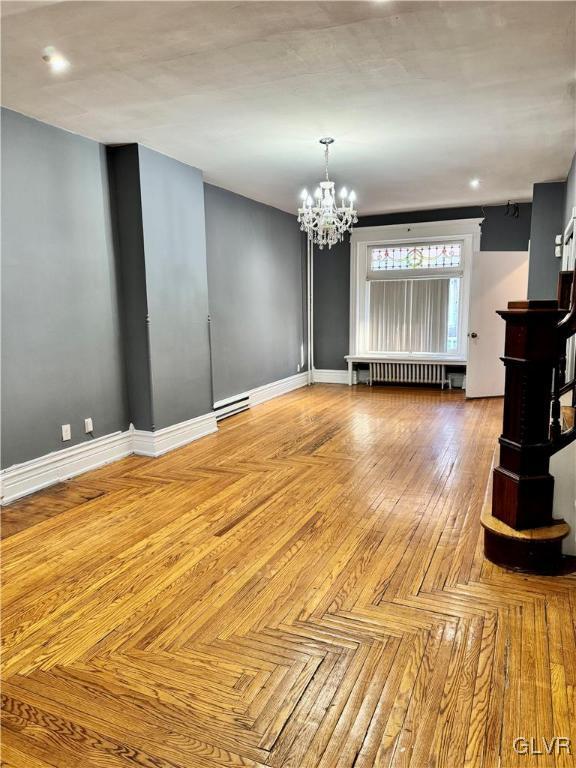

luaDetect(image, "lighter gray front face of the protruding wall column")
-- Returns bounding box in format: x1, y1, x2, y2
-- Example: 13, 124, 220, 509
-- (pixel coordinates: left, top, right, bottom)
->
138, 147, 212, 429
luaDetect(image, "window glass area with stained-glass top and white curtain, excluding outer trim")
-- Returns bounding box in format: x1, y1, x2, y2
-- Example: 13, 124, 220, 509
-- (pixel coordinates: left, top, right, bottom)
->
367, 242, 462, 355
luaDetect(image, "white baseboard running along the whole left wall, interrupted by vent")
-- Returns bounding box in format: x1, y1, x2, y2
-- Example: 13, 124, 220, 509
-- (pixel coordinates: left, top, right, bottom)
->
0, 372, 308, 504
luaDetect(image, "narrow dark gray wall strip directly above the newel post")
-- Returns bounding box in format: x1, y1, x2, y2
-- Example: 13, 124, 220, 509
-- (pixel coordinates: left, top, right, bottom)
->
528, 181, 566, 299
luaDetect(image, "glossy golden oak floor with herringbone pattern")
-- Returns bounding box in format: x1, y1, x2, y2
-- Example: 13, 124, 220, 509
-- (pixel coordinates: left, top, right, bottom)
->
3, 386, 576, 768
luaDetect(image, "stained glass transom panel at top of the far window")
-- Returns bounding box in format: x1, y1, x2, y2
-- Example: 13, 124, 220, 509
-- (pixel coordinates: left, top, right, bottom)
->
370, 243, 462, 272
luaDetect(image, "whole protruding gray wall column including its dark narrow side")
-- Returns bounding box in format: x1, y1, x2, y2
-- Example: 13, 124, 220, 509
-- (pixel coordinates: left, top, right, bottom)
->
109, 145, 212, 430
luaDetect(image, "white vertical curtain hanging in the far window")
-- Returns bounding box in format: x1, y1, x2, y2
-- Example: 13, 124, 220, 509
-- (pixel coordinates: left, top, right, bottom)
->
370, 278, 450, 353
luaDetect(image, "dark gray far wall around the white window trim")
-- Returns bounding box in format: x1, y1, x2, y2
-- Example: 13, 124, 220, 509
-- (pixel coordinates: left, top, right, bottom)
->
314, 203, 531, 370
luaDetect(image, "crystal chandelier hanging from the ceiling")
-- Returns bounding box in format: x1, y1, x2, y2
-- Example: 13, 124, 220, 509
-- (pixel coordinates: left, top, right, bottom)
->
298, 137, 358, 249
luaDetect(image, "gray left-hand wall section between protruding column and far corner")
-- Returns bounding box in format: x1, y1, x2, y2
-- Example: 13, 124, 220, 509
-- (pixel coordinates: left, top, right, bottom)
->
204, 184, 306, 401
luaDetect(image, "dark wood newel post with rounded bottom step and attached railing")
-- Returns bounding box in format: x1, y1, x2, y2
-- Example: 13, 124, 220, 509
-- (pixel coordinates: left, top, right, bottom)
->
482, 270, 576, 574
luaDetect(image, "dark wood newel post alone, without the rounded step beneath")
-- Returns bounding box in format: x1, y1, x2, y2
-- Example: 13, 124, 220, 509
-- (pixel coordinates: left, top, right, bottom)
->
492, 301, 565, 530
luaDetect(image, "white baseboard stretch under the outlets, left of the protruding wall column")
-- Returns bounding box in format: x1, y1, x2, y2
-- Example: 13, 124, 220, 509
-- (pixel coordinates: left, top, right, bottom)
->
0, 432, 132, 504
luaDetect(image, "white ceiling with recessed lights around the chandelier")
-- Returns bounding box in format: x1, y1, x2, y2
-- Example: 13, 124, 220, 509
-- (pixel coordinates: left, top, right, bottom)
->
2, 0, 576, 214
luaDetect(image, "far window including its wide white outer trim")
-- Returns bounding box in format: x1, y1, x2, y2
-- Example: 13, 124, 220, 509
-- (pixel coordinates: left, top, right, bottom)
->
347, 219, 482, 362
